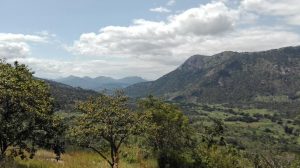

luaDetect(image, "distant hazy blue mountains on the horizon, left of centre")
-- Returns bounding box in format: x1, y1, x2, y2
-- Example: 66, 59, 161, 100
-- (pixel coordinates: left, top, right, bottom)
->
56, 76, 146, 91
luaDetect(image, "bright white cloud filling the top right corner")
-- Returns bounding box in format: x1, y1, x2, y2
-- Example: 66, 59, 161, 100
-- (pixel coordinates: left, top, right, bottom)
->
241, 0, 300, 25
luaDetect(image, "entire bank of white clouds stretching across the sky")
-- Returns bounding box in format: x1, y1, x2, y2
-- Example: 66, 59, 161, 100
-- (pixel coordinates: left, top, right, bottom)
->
5, 0, 300, 79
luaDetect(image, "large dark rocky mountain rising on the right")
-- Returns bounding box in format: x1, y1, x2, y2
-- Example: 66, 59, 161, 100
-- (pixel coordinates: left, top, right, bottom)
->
125, 46, 300, 107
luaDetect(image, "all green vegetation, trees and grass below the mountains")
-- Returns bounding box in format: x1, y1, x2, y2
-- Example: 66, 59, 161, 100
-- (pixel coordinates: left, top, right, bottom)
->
0, 58, 300, 168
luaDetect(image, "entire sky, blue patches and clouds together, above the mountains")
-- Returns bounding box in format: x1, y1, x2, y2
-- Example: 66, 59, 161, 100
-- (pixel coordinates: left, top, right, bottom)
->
0, 0, 300, 80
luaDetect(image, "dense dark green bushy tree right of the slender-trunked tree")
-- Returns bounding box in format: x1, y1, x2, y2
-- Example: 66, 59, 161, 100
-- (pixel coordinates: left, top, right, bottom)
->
140, 96, 195, 168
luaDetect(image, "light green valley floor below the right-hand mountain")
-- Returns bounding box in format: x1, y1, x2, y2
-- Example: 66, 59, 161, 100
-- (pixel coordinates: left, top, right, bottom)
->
180, 103, 300, 152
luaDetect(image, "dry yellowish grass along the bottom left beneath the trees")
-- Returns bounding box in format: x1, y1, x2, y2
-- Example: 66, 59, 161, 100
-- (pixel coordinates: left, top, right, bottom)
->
10, 149, 157, 168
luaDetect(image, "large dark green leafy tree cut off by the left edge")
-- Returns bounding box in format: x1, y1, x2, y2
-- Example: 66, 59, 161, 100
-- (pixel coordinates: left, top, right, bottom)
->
0, 61, 60, 161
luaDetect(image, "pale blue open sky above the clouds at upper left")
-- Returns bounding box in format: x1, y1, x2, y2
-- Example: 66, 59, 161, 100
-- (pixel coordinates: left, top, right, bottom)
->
0, 0, 208, 42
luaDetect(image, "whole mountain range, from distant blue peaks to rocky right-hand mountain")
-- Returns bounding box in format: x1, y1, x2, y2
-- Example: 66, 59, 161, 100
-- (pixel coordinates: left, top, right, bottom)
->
46, 46, 300, 115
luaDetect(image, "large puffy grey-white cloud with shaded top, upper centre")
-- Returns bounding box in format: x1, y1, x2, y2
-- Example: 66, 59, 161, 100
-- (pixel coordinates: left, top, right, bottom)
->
69, 2, 238, 65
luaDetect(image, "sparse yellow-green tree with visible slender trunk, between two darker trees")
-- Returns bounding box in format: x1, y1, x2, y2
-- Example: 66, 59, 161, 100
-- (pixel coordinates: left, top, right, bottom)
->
70, 91, 140, 168
